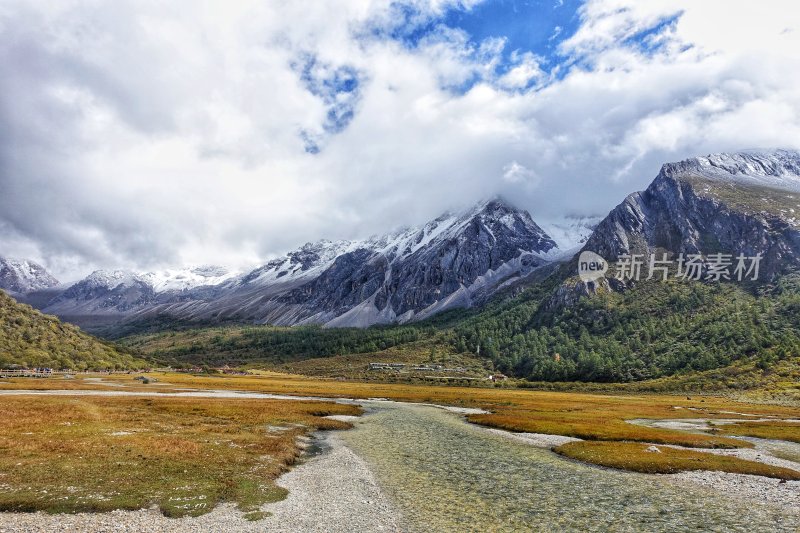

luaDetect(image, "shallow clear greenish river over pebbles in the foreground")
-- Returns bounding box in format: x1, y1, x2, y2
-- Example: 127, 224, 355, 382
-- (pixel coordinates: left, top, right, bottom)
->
340, 404, 800, 532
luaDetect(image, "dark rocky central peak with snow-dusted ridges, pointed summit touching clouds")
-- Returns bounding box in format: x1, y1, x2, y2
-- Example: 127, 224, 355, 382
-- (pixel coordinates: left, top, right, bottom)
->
281, 200, 555, 325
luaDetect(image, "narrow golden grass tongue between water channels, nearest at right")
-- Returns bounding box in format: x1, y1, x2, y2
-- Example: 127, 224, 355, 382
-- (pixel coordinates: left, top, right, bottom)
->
555, 441, 800, 480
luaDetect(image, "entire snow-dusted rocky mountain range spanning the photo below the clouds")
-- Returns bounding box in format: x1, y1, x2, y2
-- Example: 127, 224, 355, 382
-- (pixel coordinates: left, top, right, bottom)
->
0, 150, 800, 336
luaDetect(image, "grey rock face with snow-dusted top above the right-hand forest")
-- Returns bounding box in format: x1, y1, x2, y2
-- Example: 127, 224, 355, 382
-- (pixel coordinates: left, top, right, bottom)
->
584, 150, 800, 279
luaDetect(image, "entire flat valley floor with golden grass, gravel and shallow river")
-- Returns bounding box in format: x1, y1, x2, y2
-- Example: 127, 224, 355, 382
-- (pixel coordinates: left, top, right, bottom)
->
0, 374, 800, 531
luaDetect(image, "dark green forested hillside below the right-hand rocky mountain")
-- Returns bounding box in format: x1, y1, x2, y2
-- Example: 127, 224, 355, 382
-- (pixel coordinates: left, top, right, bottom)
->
453, 275, 800, 382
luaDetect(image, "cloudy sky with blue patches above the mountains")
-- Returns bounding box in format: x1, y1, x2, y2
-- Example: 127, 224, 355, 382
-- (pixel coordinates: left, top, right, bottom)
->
0, 0, 800, 280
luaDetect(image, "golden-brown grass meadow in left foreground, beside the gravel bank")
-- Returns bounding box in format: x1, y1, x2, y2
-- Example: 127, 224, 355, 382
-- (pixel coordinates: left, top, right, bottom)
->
0, 396, 360, 516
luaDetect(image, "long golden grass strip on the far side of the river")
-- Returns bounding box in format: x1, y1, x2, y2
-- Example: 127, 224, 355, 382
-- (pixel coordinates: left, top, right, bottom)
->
6, 372, 800, 480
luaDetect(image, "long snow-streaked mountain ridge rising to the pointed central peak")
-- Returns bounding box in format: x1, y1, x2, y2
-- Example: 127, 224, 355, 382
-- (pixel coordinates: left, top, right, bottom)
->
40, 199, 558, 327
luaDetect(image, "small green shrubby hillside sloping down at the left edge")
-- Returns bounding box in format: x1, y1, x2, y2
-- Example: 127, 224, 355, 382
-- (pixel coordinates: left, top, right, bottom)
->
0, 291, 147, 370
